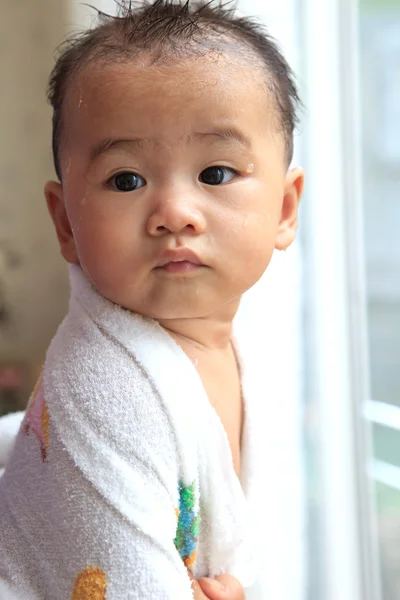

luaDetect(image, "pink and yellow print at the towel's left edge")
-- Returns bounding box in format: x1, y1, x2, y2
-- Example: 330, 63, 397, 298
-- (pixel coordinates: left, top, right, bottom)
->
24, 374, 50, 462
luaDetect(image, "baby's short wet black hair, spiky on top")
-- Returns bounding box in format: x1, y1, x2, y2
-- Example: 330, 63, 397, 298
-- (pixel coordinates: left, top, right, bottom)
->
48, 0, 300, 181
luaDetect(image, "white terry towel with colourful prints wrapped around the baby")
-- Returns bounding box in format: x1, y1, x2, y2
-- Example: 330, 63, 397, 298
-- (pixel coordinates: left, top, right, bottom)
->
0, 266, 256, 600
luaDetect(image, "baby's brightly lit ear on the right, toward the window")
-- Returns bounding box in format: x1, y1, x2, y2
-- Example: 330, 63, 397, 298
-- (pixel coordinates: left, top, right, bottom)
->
275, 169, 304, 250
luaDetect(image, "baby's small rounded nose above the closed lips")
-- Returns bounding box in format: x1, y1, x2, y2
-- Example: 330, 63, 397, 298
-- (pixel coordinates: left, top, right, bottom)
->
146, 194, 206, 237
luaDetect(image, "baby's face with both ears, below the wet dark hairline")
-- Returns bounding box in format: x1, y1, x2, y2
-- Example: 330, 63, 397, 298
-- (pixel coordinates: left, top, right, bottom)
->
46, 56, 302, 320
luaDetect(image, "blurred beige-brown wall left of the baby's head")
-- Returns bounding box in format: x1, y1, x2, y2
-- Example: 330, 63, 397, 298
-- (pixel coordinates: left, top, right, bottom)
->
0, 0, 67, 396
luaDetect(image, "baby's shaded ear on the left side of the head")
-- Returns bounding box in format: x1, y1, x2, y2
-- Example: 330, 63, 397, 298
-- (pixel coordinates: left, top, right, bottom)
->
44, 181, 78, 263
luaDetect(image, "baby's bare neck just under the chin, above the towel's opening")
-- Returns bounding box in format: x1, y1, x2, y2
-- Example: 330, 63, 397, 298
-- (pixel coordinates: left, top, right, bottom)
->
159, 301, 239, 352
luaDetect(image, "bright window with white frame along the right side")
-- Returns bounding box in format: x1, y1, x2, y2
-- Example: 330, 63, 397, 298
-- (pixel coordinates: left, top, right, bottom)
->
299, 0, 400, 600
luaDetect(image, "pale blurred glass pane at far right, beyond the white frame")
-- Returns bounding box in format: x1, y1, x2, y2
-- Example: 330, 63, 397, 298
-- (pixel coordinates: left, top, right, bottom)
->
360, 0, 400, 600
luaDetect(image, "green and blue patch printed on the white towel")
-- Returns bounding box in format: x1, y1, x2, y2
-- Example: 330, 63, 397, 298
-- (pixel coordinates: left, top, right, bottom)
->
174, 482, 200, 568
